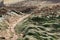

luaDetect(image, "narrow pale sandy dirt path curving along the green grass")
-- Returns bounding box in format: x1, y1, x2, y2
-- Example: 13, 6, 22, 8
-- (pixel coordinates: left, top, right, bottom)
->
9, 14, 31, 40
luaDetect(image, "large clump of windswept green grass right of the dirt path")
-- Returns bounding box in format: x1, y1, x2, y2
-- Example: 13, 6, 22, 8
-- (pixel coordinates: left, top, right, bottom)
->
15, 6, 60, 40
